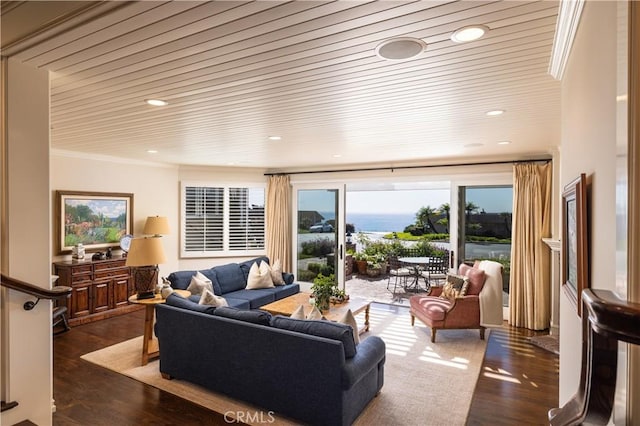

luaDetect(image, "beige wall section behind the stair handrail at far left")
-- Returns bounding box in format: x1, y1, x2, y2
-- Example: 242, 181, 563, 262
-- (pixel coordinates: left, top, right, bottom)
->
0, 59, 53, 426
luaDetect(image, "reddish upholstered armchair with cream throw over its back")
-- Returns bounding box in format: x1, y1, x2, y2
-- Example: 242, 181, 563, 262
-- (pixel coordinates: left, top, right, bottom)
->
409, 260, 502, 342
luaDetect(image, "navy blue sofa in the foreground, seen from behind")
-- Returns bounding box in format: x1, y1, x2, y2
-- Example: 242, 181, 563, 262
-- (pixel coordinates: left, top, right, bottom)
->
155, 300, 385, 426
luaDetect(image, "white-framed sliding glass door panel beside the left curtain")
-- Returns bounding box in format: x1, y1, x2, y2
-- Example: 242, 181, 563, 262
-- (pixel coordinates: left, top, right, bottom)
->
293, 184, 345, 288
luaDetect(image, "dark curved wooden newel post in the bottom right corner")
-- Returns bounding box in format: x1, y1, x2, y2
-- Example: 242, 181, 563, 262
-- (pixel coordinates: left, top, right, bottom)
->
549, 289, 640, 426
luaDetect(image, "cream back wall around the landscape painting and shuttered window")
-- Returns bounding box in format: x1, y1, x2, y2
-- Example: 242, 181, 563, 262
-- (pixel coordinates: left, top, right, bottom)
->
51, 156, 267, 276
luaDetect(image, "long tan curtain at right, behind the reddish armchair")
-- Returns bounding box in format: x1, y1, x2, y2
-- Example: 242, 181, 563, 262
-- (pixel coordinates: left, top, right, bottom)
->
509, 163, 551, 330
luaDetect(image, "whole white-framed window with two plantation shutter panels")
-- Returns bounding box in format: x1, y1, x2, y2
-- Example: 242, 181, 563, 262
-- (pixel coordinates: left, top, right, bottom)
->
181, 183, 265, 257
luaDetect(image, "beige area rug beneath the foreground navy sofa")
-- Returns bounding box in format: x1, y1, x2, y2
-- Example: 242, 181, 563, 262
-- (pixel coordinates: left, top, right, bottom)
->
82, 303, 486, 426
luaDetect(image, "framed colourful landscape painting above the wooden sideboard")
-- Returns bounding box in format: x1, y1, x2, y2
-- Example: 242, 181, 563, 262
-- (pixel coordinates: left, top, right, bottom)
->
55, 191, 133, 254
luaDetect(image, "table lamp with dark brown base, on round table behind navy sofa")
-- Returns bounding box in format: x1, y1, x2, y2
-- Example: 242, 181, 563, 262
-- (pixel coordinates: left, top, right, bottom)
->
125, 237, 167, 299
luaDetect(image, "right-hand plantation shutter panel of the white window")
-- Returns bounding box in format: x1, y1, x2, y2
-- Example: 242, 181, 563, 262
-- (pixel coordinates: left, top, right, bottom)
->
229, 188, 265, 251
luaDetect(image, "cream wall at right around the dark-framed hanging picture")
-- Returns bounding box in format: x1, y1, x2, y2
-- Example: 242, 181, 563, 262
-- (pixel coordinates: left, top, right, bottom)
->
559, 1, 617, 406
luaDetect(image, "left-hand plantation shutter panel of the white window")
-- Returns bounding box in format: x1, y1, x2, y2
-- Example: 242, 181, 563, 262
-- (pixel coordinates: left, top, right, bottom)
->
184, 186, 224, 252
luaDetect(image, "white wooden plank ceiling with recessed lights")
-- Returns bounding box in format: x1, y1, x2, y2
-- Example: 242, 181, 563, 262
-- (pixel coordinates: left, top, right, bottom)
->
2, 1, 560, 170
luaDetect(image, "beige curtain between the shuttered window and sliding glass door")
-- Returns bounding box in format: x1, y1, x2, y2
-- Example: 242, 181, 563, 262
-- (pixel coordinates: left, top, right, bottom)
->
266, 175, 292, 271
